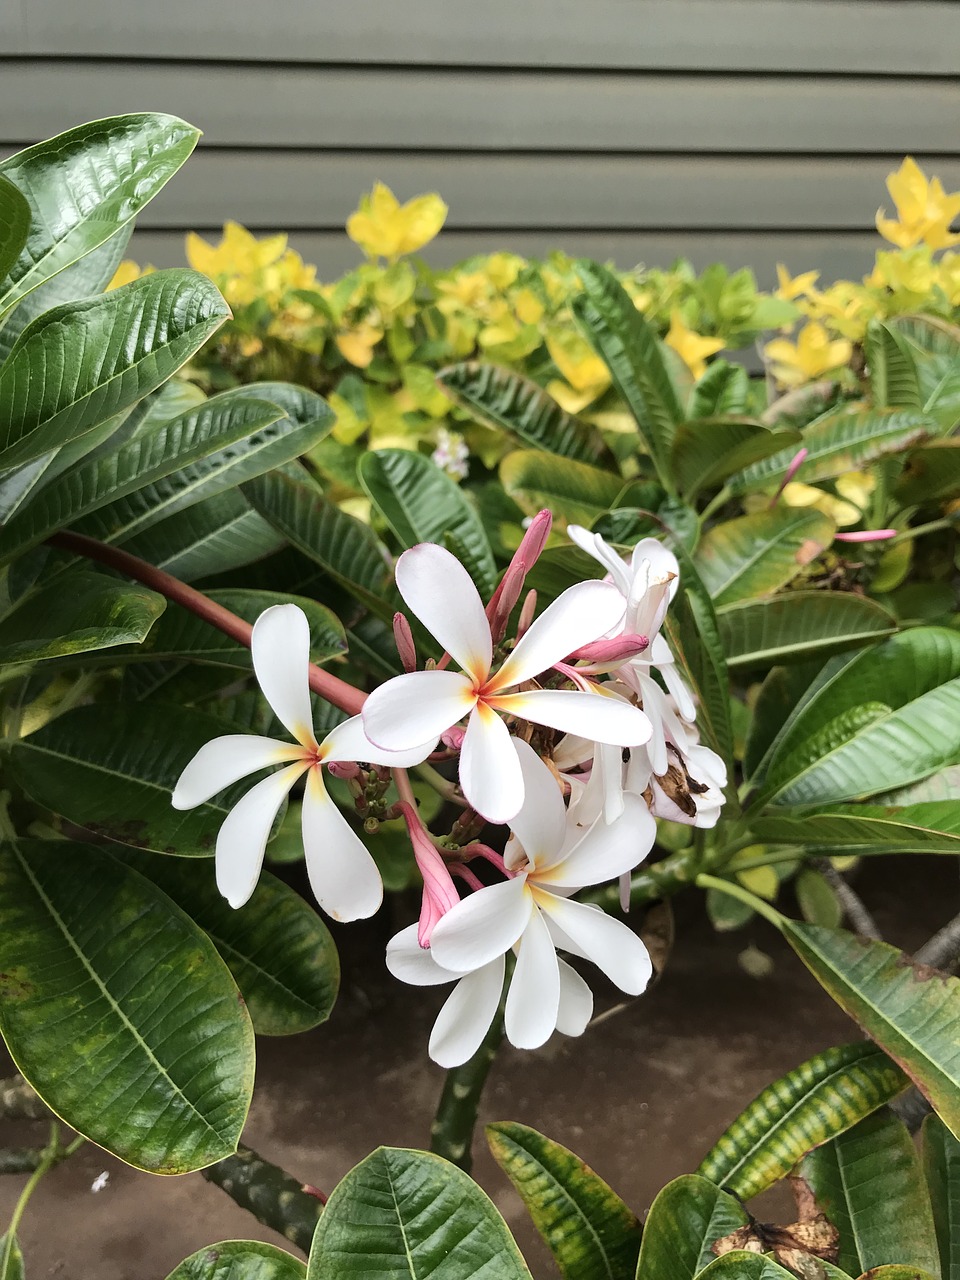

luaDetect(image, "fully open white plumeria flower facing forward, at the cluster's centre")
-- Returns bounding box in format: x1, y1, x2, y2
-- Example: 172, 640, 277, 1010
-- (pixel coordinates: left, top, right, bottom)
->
362, 543, 652, 822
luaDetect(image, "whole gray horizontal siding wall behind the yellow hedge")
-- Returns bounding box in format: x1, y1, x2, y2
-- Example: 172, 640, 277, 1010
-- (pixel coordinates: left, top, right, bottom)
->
0, 0, 960, 283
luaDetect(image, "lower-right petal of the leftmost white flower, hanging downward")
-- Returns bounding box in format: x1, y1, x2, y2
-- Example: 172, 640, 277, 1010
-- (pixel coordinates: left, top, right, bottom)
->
302, 767, 383, 922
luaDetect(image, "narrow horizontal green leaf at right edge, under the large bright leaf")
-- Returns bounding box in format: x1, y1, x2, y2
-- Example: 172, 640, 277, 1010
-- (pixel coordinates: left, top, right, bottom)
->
750, 800, 960, 858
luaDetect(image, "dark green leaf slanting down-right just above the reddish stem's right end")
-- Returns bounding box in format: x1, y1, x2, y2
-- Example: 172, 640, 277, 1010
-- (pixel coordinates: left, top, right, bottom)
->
243, 467, 393, 621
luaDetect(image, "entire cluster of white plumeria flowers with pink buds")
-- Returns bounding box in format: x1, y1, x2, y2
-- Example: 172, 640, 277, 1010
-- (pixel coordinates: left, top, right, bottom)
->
173, 512, 727, 1066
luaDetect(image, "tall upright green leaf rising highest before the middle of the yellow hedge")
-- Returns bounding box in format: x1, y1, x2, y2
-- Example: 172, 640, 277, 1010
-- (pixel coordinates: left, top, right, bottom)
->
573, 260, 684, 483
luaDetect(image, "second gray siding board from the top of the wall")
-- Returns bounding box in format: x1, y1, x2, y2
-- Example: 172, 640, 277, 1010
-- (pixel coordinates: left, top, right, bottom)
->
0, 60, 960, 155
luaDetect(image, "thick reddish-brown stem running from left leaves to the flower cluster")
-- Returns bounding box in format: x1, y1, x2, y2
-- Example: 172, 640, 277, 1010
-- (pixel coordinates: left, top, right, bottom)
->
47, 532, 366, 716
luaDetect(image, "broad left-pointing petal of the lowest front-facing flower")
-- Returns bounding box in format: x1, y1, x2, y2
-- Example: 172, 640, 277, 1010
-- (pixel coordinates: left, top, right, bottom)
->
430, 876, 534, 973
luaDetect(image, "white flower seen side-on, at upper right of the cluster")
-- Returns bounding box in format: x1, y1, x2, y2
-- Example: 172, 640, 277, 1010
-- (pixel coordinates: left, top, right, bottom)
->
567, 525, 696, 773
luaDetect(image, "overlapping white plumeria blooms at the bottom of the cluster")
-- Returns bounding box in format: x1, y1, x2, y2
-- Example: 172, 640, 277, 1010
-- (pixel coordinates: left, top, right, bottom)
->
388, 739, 655, 1065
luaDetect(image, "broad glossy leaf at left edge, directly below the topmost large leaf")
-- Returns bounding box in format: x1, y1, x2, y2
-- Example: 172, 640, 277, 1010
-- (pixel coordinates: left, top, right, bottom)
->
0, 270, 229, 467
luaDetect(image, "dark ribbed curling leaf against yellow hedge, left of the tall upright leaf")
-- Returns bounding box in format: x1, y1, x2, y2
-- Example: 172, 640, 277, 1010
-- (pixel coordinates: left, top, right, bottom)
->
436, 361, 612, 465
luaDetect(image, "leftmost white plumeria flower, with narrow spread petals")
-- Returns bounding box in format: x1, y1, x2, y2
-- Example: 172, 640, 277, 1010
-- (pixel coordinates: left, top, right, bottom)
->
173, 604, 436, 920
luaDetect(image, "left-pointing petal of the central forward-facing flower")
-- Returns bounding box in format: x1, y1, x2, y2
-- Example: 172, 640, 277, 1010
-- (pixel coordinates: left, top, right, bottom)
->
362, 671, 476, 751
